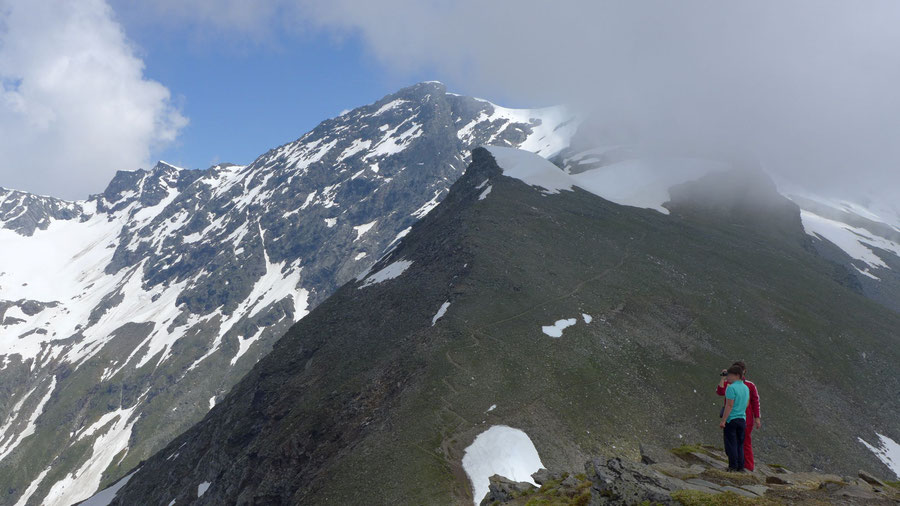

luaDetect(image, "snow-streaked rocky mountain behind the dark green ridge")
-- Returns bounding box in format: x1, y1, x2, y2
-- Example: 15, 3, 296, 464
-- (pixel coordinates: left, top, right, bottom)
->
0, 83, 576, 504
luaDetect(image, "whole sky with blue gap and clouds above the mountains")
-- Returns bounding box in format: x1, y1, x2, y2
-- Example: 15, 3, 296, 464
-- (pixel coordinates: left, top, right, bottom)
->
0, 0, 900, 198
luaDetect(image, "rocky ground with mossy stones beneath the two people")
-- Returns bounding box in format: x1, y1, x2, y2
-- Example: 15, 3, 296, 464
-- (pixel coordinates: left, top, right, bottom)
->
481, 445, 900, 506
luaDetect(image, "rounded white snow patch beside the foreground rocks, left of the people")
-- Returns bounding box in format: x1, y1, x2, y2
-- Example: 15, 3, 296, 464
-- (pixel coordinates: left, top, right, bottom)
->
462, 425, 544, 505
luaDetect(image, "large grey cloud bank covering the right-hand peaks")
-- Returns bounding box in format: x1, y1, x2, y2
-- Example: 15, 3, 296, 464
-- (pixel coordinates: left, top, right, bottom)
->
296, 0, 900, 198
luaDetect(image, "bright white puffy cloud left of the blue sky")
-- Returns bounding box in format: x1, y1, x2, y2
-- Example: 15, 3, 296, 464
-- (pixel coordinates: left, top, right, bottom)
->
0, 0, 187, 198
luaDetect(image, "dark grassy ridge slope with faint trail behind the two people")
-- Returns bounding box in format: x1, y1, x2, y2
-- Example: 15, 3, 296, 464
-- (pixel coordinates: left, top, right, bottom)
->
102, 150, 900, 504
